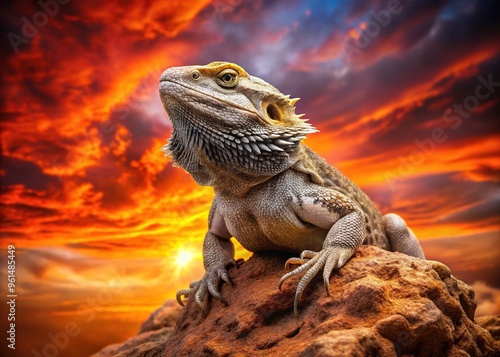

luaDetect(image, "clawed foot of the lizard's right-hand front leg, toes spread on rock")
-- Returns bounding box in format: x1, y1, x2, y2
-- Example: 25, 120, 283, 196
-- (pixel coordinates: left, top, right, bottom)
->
278, 246, 352, 315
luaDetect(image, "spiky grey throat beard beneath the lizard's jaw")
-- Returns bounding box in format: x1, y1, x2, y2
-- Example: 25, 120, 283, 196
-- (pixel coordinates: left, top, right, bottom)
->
162, 112, 317, 184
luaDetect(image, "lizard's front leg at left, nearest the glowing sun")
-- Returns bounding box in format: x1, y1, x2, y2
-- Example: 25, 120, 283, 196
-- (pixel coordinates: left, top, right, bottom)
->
176, 205, 237, 311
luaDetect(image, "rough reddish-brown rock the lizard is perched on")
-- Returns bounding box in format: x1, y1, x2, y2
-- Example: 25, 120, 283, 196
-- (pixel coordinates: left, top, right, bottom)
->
94, 246, 500, 357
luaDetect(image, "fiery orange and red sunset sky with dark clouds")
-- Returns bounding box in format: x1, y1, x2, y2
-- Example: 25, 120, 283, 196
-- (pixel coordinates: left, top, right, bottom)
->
0, 0, 500, 356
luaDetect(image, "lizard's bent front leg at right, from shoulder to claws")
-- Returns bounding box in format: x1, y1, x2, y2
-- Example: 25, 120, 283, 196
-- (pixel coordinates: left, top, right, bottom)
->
278, 190, 365, 314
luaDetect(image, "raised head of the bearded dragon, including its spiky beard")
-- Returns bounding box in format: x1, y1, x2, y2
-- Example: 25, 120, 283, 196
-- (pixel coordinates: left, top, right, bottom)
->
159, 62, 317, 185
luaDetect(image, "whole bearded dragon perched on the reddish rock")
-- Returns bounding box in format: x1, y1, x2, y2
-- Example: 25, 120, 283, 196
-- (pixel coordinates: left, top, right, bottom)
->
159, 62, 425, 314
